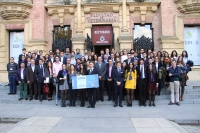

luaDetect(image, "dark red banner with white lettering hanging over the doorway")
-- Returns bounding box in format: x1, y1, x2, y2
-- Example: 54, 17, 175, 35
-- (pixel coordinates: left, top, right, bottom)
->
92, 26, 113, 45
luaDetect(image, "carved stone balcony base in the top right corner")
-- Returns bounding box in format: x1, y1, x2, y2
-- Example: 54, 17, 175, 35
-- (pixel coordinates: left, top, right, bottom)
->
174, 0, 200, 14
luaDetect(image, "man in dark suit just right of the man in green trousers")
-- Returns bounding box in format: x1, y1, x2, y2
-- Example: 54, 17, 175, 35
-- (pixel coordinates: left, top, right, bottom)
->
26, 59, 38, 101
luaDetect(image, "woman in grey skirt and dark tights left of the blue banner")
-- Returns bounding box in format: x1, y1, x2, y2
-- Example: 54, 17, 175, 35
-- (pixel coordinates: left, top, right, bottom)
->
58, 64, 69, 107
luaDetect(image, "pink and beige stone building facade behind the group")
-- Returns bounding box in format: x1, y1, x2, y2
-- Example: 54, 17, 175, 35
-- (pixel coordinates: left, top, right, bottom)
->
0, 0, 200, 82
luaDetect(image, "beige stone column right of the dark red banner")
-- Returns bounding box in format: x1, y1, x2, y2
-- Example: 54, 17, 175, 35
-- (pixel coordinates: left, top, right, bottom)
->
118, 0, 133, 50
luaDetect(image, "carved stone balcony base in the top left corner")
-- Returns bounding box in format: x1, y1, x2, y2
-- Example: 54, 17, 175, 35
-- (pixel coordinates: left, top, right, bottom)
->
0, 0, 32, 20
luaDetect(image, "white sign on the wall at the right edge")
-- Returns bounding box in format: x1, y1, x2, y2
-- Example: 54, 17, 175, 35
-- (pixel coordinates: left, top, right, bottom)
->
184, 26, 200, 65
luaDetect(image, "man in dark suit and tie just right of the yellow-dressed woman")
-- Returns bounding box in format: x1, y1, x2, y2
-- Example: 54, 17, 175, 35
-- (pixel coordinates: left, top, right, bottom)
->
137, 58, 147, 106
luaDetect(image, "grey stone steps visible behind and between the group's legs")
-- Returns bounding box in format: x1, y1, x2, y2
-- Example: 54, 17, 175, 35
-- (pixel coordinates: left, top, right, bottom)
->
0, 81, 200, 106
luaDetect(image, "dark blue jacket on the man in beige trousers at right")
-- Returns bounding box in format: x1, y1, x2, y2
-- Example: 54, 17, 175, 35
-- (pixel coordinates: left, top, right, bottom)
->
169, 66, 181, 82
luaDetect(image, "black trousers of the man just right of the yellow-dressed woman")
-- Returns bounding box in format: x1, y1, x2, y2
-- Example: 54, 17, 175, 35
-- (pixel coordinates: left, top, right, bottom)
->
138, 79, 147, 104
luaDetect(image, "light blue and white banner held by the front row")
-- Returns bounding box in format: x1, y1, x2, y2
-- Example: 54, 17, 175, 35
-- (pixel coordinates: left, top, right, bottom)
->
72, 74, 99, 89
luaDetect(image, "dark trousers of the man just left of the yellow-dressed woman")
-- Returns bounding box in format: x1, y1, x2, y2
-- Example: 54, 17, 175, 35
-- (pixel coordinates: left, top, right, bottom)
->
114, 83, 123, 105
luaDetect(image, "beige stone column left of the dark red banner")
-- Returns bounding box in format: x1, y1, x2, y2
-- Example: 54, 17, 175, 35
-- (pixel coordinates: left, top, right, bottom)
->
72, 0, 85, 53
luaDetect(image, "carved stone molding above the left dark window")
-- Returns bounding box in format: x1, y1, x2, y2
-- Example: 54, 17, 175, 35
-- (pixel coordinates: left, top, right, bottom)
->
45, 5, 76, 26
